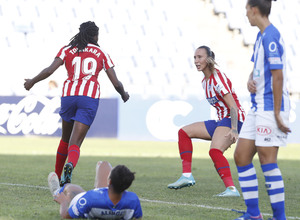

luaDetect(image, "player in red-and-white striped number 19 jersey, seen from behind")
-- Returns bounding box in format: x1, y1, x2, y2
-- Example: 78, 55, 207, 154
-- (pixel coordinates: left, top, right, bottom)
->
24, 21, 129, 185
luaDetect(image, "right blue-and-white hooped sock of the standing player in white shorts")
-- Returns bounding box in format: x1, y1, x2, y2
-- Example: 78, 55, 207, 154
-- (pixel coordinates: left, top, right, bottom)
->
261, 163, 286, 220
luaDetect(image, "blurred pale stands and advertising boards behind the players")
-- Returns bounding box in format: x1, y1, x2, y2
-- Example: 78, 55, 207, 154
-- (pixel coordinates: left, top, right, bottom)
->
0, 0, 300, 142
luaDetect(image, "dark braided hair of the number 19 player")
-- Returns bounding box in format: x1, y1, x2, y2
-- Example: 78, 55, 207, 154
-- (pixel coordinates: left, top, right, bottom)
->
69, 21, 99, 52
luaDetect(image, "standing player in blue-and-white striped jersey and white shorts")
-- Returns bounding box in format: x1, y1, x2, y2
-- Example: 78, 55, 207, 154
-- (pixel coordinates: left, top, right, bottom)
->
234, 0, 290, 220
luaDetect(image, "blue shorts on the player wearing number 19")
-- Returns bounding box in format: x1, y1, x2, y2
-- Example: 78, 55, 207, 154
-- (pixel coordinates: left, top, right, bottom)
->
59, 96, 99, 126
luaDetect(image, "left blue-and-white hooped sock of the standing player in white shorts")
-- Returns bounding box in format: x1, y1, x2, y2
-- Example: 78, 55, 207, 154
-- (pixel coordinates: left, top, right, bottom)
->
237, 163, 260, 216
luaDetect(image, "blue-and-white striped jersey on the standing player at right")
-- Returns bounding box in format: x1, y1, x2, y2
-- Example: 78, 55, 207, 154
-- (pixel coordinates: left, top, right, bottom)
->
251, 24, 289, 111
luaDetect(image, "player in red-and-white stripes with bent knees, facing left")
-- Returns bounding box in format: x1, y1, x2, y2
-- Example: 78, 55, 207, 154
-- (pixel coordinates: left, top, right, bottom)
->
168, 46, 245, 197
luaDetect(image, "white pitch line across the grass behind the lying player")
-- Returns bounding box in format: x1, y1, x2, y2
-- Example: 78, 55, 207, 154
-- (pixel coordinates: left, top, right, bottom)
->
0, 183, 300, 219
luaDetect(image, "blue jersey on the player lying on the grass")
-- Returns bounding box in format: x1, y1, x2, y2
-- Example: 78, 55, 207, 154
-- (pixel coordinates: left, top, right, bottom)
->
68, 187, 143, 220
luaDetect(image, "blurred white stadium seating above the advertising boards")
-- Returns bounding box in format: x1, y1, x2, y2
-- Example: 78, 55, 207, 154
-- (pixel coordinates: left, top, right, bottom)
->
0, 0, 300, 98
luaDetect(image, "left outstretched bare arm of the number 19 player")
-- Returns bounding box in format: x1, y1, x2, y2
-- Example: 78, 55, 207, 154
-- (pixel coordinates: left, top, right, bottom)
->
24, 57, 63, 90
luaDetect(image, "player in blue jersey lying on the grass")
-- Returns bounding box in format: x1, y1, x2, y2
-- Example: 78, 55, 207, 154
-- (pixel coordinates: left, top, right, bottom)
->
48, 161, 143, 220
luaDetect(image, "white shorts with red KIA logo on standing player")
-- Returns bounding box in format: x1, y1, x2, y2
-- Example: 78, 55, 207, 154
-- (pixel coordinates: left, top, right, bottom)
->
239, 109, 289, 147
